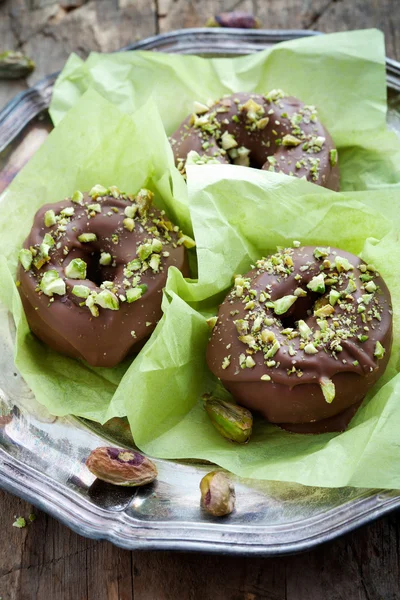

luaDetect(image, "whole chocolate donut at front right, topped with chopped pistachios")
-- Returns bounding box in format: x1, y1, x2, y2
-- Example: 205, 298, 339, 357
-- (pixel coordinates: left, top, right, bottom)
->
207, 242, 392, 433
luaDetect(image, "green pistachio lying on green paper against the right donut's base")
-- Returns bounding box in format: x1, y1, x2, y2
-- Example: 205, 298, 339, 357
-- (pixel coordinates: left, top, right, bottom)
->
204, 396, 253, 444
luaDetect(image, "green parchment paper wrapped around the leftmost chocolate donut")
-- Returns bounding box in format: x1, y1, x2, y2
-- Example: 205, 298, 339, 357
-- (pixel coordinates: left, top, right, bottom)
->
0, 91, 191, 422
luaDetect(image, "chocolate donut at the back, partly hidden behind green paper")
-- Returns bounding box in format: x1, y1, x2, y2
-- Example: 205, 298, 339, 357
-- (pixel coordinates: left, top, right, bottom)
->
170, 90, 339, 191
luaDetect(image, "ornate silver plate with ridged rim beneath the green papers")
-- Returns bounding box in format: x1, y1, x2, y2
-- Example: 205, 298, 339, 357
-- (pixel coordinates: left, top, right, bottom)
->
0, 29, 400, 555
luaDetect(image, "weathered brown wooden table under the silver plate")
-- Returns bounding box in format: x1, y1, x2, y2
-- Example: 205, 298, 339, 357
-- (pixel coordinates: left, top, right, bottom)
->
0, 0, 400, 600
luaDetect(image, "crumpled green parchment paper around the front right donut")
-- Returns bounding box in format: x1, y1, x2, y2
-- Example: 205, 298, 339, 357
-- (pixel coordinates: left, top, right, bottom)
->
116, 165, 400, 488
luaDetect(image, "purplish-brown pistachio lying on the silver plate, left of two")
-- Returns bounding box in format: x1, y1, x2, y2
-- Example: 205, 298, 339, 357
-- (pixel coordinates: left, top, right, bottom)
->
86, 446, 158, 487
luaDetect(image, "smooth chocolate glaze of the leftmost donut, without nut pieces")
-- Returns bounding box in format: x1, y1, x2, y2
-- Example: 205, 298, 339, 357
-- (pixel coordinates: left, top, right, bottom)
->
18, 194, 189, 367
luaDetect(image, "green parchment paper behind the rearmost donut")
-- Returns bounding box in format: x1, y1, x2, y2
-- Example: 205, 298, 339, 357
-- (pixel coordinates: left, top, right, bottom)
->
50, 29, 400, 190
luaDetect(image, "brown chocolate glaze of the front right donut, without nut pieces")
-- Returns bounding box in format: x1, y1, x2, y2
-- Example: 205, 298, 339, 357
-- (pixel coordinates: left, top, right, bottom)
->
207, 247, 392, 432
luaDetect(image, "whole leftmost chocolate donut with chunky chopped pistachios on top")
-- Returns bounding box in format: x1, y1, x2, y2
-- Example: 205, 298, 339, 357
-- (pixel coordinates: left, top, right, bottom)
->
18, 185, 194, 367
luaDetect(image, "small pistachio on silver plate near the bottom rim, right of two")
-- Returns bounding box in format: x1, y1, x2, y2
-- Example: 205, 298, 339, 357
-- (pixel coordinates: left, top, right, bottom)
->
200, 471, 236, 517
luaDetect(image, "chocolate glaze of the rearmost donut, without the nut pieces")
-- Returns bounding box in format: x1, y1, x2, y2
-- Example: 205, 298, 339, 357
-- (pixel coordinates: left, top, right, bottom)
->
170, 93, 339, 191
